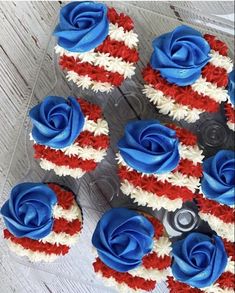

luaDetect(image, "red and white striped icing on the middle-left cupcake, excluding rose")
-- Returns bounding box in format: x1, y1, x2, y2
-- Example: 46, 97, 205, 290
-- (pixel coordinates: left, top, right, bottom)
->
31, 99, 109, 178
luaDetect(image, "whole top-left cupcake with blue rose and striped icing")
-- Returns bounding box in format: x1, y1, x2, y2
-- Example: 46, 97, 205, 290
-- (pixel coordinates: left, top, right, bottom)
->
54, 2, 139, 92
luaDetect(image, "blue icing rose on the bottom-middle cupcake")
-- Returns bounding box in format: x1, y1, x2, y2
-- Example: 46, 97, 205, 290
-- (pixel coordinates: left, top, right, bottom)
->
92, 208, 154, 272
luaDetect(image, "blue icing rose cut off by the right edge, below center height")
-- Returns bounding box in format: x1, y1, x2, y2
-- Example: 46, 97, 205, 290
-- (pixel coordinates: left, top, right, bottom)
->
201, 150, 235, 205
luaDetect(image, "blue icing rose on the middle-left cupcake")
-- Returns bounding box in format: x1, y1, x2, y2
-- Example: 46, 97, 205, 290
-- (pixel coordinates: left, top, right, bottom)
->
29, 96, 85, 149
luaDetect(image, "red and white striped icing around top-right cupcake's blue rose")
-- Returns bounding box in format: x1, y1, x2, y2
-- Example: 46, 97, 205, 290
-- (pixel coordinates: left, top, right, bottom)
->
143, 34, 233, 123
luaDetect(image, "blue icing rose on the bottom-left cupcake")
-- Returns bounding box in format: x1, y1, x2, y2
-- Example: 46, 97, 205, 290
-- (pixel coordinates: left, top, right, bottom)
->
1, 183, 57, 240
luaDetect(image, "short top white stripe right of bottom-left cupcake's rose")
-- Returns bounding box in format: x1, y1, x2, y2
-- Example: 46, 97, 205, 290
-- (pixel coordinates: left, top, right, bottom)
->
53, 200, 82, 223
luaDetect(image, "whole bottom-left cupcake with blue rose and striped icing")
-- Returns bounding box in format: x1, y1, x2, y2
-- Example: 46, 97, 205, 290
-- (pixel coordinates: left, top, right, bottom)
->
1, 182, 82, 262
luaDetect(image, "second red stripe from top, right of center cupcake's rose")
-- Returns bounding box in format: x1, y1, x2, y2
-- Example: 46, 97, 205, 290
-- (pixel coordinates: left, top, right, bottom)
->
173, 159, 202, 178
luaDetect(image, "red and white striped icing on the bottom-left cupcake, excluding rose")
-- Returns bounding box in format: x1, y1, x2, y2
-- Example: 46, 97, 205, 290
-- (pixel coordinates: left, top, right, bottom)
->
3, 183, 83, 262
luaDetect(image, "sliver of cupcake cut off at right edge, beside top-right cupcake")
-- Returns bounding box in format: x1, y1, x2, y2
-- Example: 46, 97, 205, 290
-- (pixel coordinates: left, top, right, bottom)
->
224, 70, 235, 131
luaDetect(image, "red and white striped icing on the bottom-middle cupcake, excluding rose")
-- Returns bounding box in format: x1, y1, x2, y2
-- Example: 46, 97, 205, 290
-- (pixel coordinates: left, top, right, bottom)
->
93, 214, 171, 292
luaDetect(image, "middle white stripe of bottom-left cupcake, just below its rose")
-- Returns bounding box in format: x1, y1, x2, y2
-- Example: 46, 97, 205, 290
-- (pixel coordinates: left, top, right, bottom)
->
39, 231, 80, 247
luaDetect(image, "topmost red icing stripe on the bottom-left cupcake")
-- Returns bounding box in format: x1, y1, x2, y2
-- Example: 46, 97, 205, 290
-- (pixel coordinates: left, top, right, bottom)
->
47, 183, 74, 210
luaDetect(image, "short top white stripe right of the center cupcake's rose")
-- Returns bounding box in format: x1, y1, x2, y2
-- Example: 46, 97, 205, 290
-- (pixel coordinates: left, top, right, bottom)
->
179, 143, 204, 165
